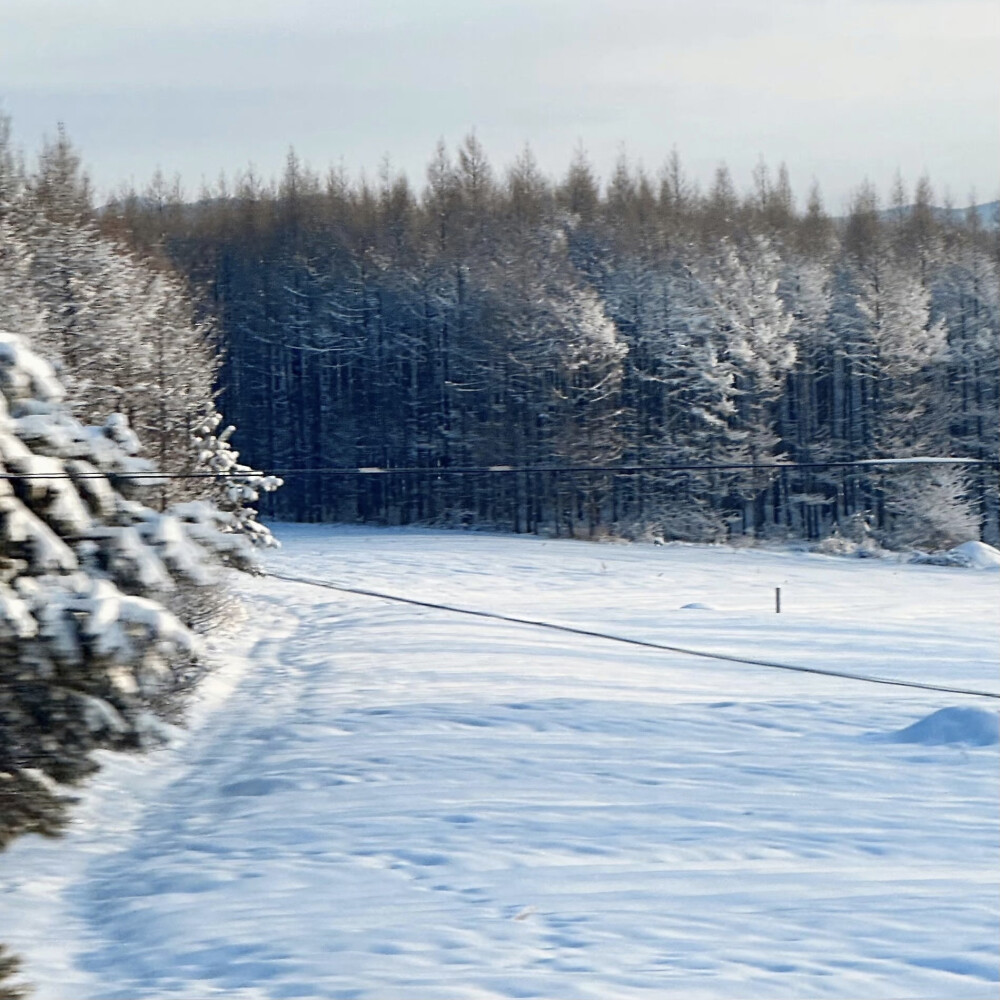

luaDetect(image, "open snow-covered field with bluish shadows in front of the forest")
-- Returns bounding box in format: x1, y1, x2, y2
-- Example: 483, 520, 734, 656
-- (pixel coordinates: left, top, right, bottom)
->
0, 526, 1000, 1000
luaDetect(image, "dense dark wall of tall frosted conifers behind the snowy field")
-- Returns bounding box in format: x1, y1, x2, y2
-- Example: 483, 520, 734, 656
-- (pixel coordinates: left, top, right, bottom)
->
107, 135, 998, 548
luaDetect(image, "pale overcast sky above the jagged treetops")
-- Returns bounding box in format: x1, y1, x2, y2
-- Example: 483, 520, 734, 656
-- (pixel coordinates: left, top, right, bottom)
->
0, 0, 1000, 211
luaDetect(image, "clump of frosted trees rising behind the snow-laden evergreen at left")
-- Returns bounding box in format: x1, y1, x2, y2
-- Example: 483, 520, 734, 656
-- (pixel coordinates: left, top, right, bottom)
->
0, 121, 279, 544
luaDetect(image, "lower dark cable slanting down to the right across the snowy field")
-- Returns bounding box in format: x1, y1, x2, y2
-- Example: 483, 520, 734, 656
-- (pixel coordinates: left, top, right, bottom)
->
265, 573, 1000, 699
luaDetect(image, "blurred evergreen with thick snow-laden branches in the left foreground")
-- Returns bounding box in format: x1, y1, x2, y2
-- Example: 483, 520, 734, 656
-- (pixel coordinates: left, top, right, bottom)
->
0, 331, 251, 846
